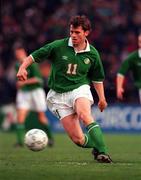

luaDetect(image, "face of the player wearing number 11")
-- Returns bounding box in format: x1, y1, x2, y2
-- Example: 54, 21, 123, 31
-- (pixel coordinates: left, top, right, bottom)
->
70, 25, 89, 46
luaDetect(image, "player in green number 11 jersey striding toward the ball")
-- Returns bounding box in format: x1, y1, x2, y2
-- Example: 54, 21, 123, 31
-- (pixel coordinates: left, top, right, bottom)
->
17, 15, 112, 163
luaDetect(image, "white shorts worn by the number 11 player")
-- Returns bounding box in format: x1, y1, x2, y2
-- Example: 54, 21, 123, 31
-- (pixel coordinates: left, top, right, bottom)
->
47, 85, 94, 120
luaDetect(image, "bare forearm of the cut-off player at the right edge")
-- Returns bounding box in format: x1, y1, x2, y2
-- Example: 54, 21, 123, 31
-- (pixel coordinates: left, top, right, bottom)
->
116, 74, 125, 100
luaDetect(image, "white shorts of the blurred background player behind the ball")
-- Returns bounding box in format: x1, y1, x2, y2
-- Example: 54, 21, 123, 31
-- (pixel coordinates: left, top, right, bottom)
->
16, 88, 47, 112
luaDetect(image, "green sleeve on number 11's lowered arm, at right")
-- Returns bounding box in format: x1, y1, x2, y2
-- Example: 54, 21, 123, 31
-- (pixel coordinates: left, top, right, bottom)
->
89, 50, 105, 82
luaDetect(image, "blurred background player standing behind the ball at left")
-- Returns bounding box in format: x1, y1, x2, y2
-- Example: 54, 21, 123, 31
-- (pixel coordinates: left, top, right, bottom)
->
14, 45, 54, 147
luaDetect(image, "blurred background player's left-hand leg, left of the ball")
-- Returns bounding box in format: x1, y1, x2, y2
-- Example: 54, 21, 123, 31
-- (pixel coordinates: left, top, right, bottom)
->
15, 109, 28, 146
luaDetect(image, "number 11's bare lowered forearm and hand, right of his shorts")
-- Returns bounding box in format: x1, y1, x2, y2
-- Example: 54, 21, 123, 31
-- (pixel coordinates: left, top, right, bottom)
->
93, 82, 107, 112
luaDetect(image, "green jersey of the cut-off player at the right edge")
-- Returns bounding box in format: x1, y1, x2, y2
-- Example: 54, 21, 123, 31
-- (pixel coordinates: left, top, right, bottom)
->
118, 51, 141, 88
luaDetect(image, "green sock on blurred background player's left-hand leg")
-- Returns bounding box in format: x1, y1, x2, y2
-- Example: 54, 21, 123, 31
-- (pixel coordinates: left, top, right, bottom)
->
16, 124, 25, 145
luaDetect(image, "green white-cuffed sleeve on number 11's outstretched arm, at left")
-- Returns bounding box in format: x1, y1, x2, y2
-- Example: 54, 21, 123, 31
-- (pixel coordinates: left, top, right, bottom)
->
30, 43, 53, 63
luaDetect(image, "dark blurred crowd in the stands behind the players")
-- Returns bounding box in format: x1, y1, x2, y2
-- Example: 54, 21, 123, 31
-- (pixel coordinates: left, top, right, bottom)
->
0, 0, 141, 105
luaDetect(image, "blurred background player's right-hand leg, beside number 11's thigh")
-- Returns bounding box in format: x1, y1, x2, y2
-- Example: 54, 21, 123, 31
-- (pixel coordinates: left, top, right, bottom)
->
38, 111, 54, 147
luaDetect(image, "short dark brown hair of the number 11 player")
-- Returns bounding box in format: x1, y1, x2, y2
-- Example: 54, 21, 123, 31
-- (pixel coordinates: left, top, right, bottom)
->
69, 15, 91, 31
